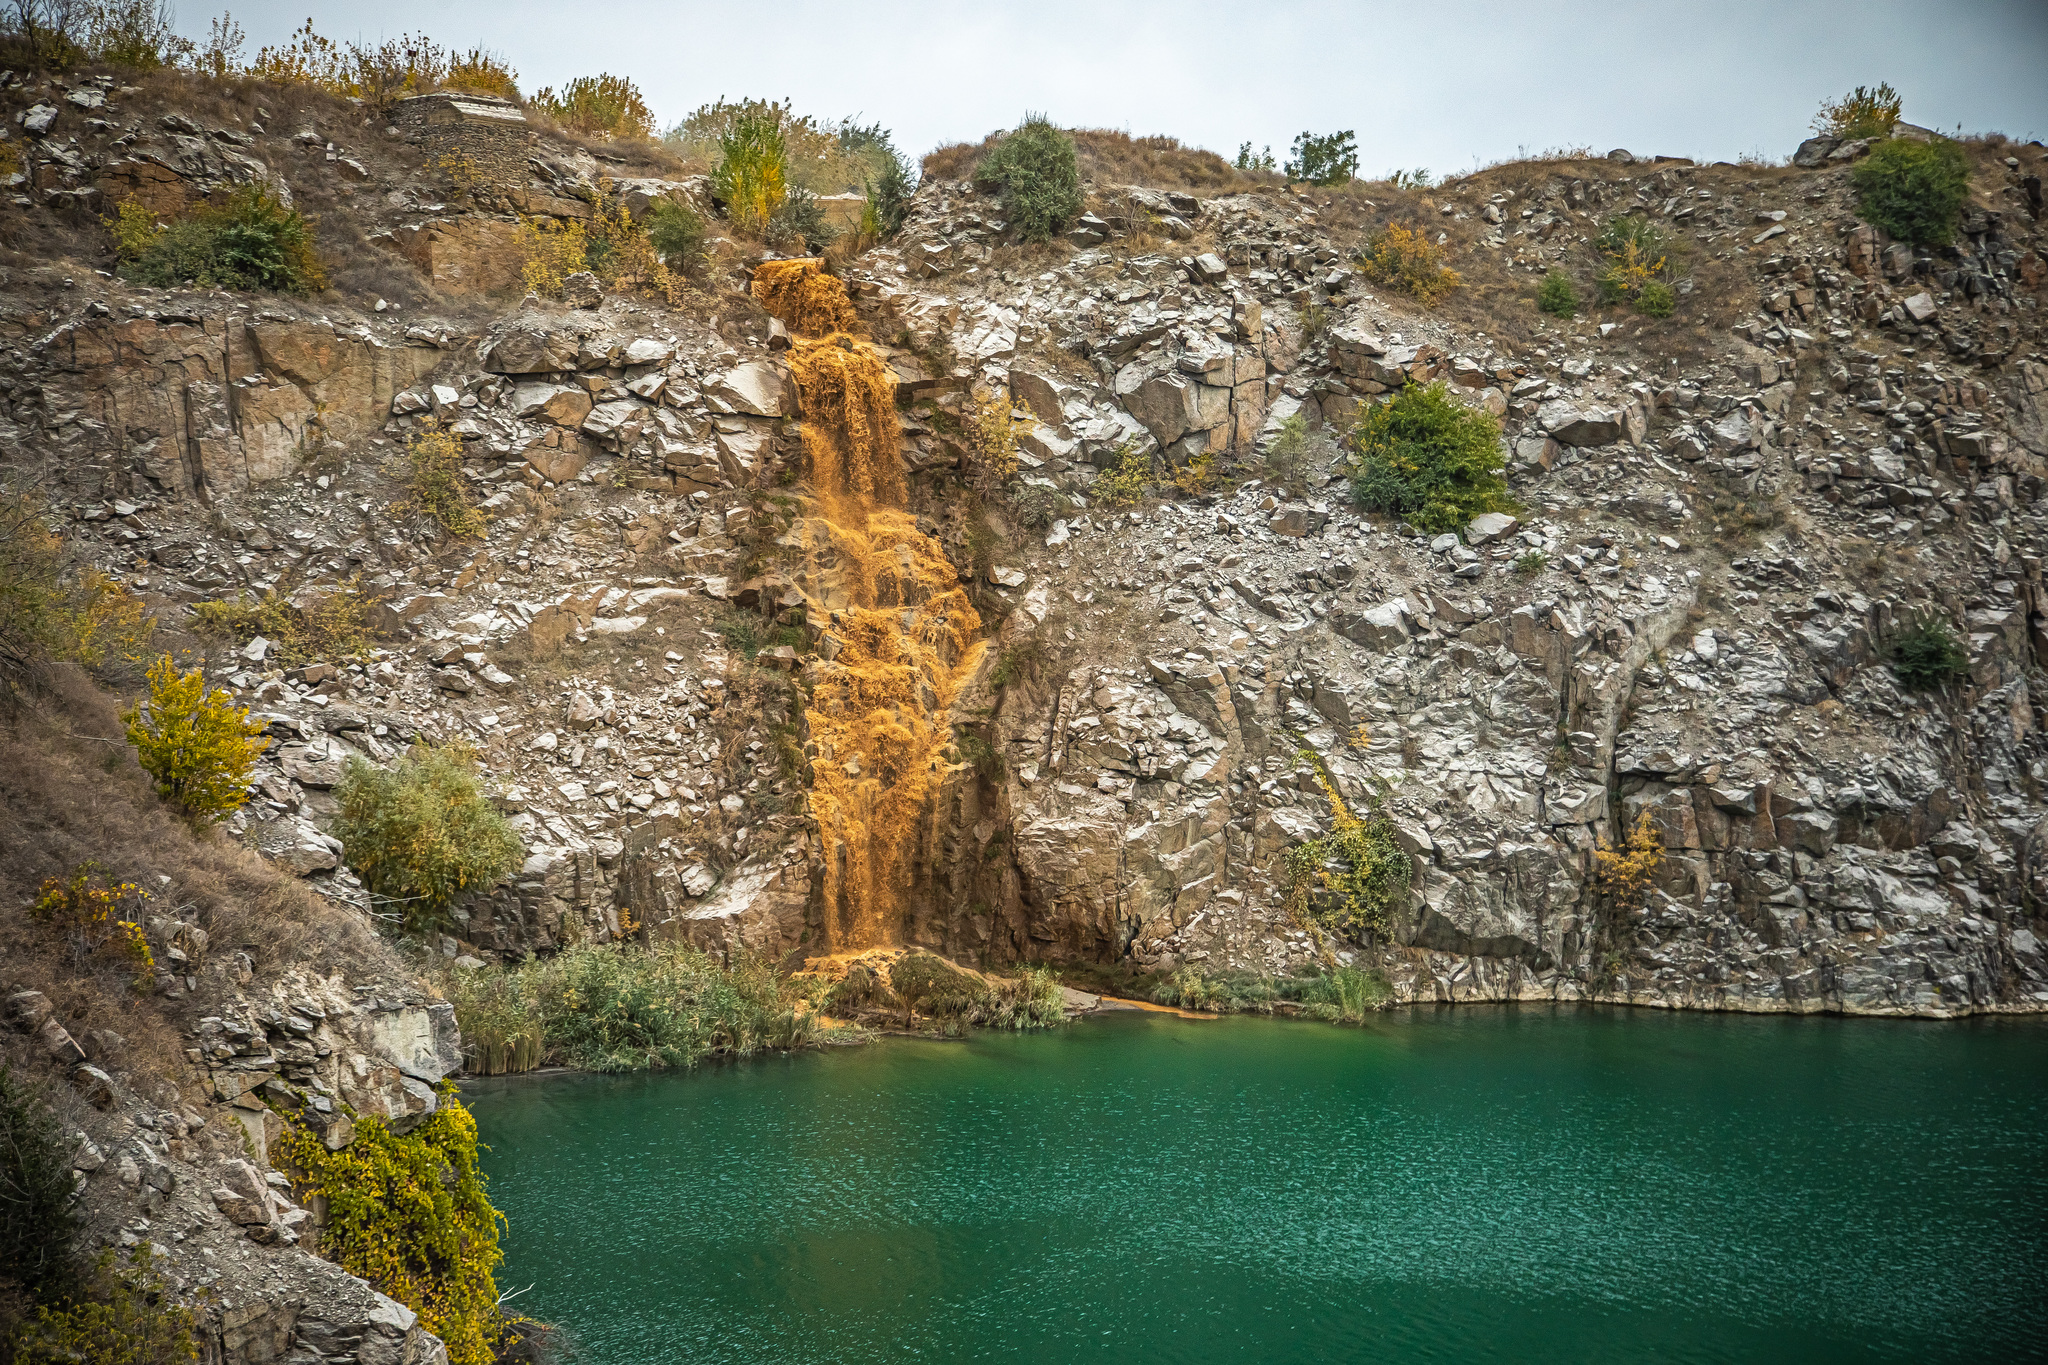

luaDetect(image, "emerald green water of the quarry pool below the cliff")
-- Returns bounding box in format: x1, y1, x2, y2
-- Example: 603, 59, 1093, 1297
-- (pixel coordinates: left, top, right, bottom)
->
467, 1007, 2048, 1365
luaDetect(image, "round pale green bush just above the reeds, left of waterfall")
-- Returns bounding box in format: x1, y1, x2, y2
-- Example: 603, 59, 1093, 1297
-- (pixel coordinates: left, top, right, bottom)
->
334, 745, 518, 933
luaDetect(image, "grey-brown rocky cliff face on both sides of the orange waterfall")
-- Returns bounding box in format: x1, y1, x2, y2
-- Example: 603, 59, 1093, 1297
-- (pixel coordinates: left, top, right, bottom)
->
4, 74, 2048, 1080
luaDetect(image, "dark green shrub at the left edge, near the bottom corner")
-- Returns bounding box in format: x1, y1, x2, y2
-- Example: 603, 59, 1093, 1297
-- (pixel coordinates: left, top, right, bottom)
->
0, 1066, 80, 1297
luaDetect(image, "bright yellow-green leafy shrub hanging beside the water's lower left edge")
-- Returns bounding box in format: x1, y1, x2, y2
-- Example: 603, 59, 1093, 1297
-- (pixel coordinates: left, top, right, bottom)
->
279, 1085, 508, 1365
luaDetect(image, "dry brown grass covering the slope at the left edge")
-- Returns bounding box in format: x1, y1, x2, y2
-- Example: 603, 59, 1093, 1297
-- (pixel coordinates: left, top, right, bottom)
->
0, 665, 395, 1076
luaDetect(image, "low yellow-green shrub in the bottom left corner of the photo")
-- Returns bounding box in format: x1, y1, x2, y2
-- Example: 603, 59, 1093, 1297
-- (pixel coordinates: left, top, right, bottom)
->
10, 1242, 199, 1365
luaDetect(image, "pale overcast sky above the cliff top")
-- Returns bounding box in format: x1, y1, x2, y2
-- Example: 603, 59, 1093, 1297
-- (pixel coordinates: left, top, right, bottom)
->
203, 0, 2048, 176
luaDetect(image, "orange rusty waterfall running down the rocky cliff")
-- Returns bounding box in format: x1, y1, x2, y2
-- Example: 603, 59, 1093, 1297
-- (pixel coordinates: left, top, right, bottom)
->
754, 260, 985, 952
